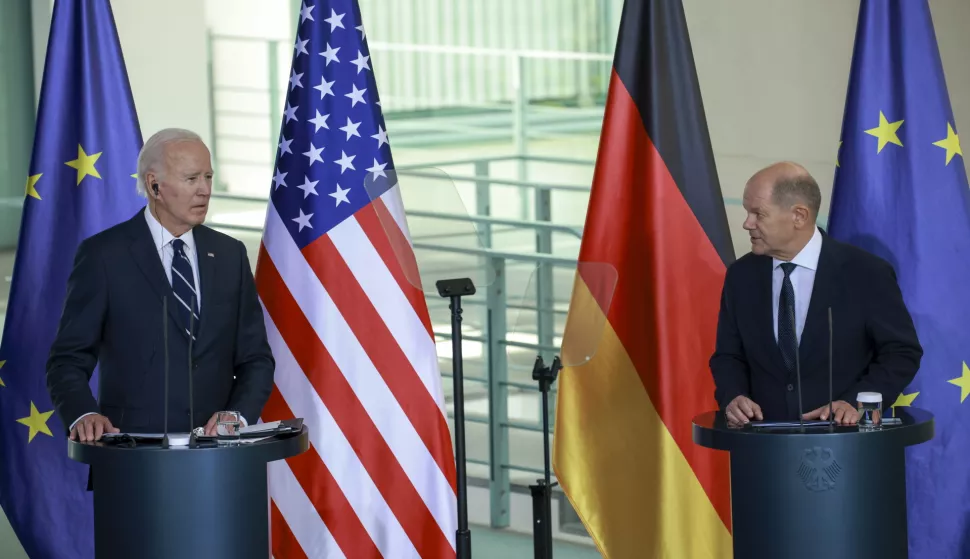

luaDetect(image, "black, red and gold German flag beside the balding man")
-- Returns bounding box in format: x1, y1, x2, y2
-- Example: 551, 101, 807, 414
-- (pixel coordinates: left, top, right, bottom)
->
553, 0, 734, 559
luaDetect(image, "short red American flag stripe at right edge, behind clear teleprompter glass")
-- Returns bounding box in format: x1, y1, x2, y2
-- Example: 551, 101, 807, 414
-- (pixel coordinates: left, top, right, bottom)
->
354, 202, 434, 339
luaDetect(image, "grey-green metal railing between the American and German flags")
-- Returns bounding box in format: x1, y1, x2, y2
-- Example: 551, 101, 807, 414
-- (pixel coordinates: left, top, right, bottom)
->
208, 148, 593, 528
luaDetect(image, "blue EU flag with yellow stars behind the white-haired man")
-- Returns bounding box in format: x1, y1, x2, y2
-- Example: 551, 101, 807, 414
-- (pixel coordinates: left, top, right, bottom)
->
0, 0, 145, 559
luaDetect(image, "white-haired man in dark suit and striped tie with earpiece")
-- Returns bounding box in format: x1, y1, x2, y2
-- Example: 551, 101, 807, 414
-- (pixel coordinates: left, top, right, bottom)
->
47, 129, 275, 441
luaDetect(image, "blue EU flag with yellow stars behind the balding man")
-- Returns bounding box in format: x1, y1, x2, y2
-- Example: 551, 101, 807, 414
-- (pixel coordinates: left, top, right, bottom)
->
829, 0, 970, 559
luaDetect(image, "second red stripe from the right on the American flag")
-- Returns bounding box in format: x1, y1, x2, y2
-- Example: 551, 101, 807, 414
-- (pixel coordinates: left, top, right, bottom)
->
303, 235, 456, 491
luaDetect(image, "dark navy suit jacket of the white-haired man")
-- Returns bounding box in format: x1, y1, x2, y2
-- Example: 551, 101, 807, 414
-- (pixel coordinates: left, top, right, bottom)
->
47, 210, 275, 433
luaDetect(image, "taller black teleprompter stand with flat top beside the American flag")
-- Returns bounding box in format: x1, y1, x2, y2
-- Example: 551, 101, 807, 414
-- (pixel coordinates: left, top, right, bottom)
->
435, 278, 475, 559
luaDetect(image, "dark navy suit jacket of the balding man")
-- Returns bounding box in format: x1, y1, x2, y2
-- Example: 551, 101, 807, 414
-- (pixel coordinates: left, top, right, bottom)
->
710, 235, 923, 420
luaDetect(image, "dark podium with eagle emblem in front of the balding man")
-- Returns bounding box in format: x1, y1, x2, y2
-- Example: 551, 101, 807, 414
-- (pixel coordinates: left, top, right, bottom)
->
693, 408, 934, 559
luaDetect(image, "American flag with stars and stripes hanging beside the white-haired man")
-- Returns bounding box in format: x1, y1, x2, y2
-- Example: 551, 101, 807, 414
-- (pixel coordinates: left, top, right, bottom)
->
256, 0, 457, 559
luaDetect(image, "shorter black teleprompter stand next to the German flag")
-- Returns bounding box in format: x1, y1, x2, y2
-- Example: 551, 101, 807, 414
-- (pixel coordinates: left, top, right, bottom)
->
529, 355, 562, 559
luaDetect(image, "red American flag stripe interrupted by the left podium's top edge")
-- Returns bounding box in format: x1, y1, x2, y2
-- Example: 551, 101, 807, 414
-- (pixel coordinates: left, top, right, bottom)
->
262, 388, 381, 557
